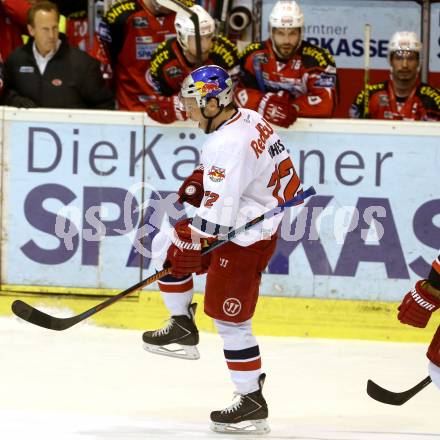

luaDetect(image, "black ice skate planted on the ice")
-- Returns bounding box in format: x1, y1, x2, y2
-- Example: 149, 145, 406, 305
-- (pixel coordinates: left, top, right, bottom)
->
211, 373, 270, 434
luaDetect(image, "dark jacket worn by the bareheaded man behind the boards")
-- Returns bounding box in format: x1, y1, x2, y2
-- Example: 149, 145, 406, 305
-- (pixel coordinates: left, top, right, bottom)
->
3, 35, 114, 109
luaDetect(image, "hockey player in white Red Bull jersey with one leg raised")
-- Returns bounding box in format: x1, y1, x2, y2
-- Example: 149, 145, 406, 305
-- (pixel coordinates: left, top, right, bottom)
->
143, 65, 301, 433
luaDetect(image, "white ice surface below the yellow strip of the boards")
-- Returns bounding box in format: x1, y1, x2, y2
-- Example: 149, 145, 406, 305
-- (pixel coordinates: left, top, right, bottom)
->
0, 318, 440, 440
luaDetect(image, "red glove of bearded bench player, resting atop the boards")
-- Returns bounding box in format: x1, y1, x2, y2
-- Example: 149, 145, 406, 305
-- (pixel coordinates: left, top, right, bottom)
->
258, 91, 298, 128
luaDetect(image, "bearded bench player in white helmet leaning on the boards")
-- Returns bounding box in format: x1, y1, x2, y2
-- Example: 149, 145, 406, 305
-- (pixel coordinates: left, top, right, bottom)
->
237, 1, 337, 127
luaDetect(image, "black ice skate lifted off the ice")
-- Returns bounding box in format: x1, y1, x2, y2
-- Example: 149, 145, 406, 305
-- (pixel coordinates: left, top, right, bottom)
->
142, 303, 200, 360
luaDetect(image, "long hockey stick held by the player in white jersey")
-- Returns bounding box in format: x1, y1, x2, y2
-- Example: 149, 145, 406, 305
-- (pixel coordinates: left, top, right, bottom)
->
11, 186, 316, 330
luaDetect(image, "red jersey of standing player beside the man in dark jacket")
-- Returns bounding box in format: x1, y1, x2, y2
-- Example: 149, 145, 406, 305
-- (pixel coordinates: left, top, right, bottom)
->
105, 1, 175, 111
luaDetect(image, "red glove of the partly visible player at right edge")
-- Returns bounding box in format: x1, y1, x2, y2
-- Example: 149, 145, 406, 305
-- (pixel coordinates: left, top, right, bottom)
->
397, 280, 440, 328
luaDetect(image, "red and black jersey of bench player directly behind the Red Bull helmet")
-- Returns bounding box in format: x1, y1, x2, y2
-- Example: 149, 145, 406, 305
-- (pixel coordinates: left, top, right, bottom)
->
149, 35, 240, 96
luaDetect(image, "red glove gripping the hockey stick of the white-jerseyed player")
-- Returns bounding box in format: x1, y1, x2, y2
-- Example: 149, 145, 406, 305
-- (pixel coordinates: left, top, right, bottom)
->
165, 219, 202, 278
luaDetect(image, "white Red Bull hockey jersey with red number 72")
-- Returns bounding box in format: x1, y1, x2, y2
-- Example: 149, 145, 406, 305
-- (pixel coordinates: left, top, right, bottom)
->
192, 108, 300, 246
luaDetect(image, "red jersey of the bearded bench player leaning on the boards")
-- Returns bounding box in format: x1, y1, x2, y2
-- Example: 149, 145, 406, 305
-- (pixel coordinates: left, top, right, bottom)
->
237, 39, 337, 117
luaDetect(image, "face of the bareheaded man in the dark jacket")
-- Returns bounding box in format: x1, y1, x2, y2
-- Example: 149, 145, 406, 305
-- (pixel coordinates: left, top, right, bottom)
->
28, 10, 59, 55
